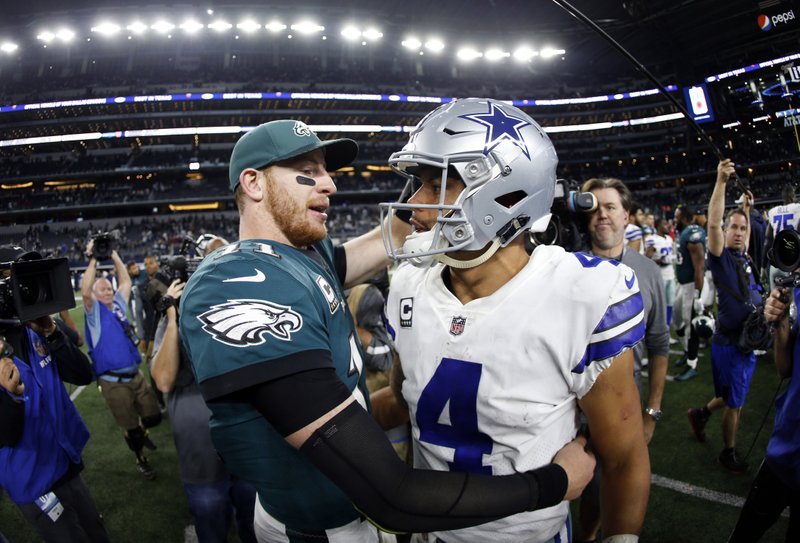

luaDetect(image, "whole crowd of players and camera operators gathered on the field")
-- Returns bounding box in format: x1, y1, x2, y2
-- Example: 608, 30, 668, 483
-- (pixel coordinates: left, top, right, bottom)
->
0, 98, 800, 543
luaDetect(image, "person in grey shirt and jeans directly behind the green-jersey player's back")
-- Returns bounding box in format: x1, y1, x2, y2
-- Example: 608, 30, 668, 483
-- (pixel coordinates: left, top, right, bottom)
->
145, 236, 256, 543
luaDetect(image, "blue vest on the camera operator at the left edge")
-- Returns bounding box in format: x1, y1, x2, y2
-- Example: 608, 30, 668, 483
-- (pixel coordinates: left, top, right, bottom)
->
0, 330, 89, 504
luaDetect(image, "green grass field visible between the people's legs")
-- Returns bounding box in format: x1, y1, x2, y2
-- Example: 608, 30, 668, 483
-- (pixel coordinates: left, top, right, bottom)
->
0, 310, 788, 543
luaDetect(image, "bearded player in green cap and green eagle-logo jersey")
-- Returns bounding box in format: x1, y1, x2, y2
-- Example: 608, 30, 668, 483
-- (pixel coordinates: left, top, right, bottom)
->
180, 120, 594, 543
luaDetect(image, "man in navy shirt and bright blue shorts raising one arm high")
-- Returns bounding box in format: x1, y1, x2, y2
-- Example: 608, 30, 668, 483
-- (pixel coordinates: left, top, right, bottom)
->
688, 159, 761, 473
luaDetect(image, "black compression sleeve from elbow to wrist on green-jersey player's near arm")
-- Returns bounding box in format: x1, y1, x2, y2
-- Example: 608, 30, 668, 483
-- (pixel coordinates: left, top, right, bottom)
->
300, 403, 567, 532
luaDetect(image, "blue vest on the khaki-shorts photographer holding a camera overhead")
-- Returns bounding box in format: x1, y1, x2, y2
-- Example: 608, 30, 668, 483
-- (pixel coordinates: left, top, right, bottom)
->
84, 296, 142, 376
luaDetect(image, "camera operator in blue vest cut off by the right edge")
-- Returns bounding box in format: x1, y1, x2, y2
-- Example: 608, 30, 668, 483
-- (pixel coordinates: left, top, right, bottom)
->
728, 288, 800, 543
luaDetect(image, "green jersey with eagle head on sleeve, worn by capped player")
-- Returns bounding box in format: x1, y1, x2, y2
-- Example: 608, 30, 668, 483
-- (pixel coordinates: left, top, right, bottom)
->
180, 239, 368, 530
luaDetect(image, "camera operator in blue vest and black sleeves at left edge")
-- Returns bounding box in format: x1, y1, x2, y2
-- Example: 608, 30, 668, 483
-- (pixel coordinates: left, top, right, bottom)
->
0, 246, 108, 543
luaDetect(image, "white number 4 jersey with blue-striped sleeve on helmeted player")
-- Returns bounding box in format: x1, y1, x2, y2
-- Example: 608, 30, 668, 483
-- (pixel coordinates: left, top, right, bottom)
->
387, 246, 644, 543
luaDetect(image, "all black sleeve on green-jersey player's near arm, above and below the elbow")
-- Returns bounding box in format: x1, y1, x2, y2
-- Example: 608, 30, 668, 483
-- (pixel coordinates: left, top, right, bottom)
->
245, 368, 568, 532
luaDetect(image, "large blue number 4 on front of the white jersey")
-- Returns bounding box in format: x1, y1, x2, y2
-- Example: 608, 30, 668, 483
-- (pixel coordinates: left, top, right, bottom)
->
417, 358, 492, 475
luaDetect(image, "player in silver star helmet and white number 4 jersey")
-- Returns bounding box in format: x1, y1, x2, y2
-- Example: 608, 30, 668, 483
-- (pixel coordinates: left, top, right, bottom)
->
381, 98, 650, 543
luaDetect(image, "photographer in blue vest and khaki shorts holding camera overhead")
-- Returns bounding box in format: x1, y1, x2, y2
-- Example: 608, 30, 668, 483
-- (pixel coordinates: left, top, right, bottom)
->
81, 239, 161, 479
